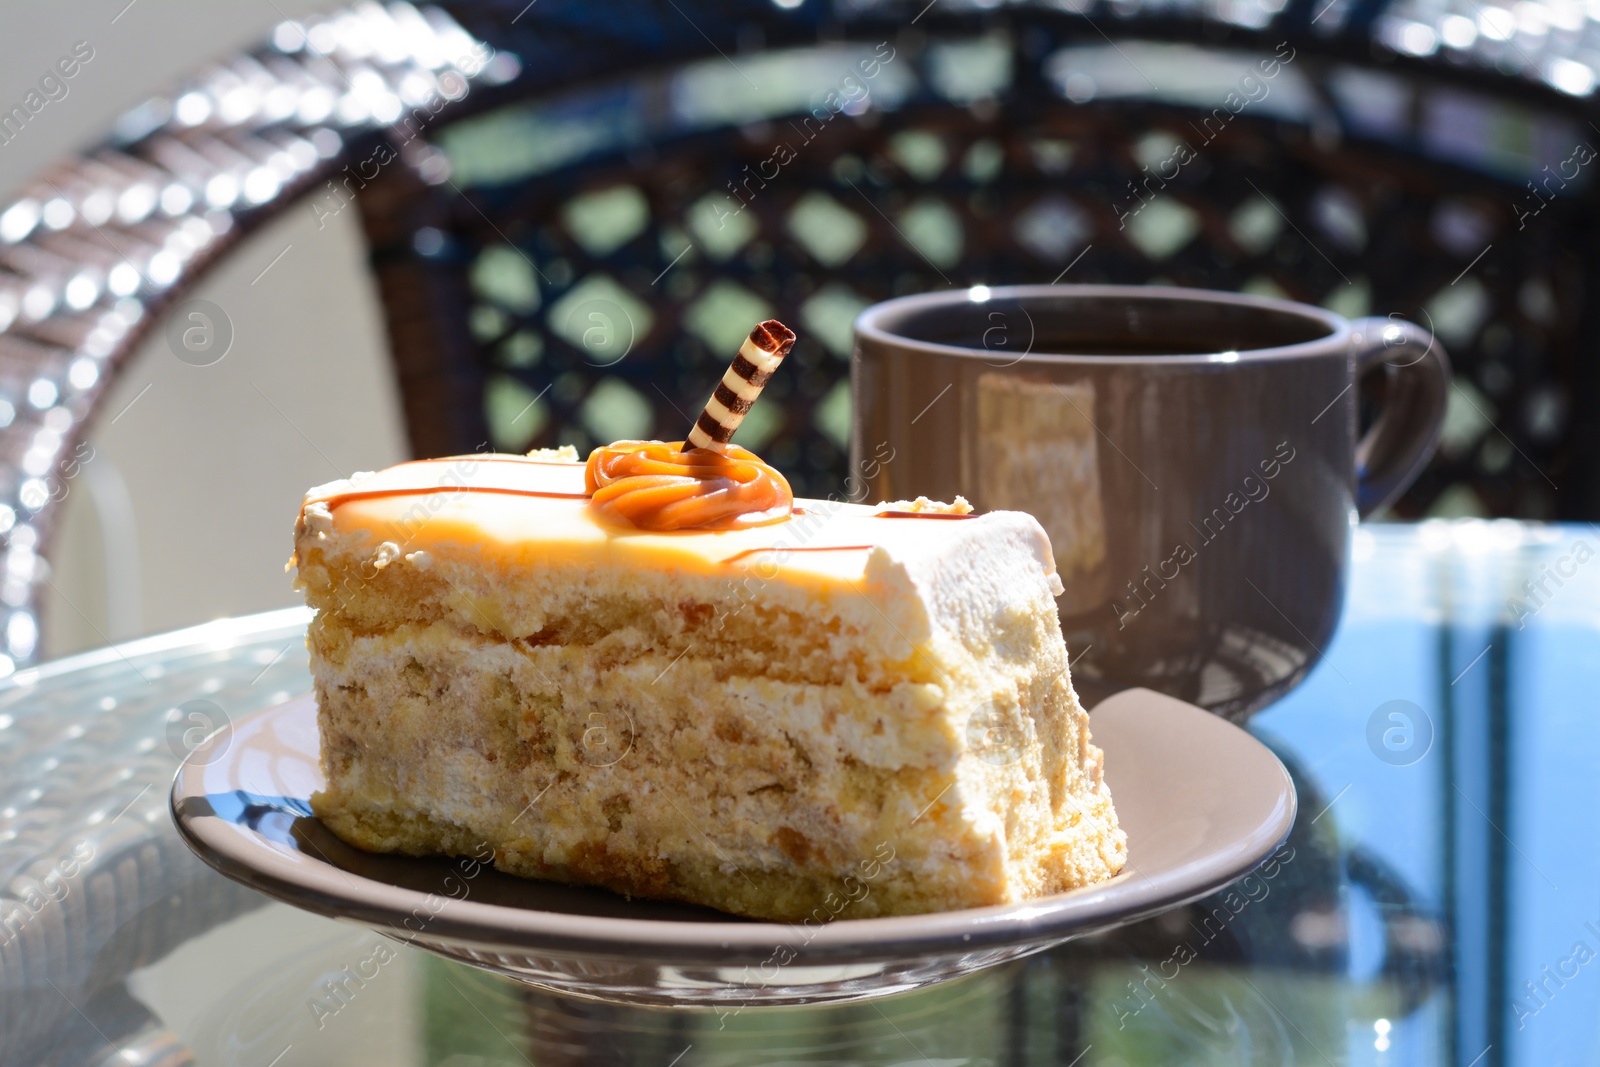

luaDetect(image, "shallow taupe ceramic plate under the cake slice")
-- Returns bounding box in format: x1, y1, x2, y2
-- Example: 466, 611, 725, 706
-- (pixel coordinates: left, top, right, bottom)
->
173, 689, 1294, 1005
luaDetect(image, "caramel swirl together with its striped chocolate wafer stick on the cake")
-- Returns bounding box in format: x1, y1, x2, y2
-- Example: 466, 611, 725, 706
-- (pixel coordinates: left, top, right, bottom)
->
584, 320, 795, 531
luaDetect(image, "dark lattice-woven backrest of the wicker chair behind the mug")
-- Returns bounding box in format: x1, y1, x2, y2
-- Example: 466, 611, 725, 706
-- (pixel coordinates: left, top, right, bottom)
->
365, 0, 1600, 517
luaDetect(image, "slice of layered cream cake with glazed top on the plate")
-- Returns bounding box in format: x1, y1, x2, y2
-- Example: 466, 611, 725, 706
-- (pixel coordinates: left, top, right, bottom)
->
291, 443, 1126, 921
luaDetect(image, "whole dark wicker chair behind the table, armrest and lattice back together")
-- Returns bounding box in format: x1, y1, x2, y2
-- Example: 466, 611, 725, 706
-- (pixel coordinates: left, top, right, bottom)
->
0, 0, 1600, 661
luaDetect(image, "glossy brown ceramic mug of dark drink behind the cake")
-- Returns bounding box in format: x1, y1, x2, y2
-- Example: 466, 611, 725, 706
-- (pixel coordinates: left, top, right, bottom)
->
851, 285, 1450, 718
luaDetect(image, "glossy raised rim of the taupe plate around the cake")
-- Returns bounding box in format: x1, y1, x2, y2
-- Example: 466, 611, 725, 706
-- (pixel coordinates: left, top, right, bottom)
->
168, 689, 1299, 966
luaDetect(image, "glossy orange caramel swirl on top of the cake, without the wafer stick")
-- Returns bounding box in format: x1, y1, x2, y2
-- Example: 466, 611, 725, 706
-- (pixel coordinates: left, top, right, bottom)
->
584, 442, 795, 531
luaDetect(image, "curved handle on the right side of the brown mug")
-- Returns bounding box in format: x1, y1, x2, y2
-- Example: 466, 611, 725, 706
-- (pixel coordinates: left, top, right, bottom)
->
1352, 318, 1450, 518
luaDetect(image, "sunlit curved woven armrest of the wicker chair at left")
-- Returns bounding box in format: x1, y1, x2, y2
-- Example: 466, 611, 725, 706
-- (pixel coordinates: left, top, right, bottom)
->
0, 3, 517, 677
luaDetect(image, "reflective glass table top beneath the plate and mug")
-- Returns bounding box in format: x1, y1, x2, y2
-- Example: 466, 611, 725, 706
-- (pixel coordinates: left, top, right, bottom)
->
0, 522, 1600, 1067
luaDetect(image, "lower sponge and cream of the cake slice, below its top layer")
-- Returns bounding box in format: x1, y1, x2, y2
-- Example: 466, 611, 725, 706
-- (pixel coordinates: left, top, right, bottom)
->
312, 617, 1123, 921
